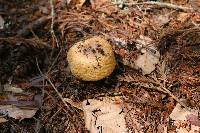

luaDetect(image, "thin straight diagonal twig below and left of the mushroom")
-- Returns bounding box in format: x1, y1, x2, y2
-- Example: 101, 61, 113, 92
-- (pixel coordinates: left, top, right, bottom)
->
36, 58, 72, 112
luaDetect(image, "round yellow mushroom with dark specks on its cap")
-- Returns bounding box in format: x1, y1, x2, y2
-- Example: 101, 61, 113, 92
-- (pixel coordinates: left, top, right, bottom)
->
67, 36, 116, 81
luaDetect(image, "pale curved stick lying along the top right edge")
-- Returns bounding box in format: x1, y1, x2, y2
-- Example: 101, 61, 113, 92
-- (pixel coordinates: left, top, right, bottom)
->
126, 1, 193, 11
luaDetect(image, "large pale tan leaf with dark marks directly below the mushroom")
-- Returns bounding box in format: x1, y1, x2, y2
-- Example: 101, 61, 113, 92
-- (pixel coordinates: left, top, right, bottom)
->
82, 99, 127, 133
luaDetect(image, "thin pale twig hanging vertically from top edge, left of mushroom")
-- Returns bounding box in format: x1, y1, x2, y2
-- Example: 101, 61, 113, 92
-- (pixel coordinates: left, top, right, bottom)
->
50, 0, 59, 47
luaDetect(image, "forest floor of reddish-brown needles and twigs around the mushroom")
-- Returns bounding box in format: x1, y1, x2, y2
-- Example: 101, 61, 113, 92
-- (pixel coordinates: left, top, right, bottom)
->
0, 0, 200, 133
